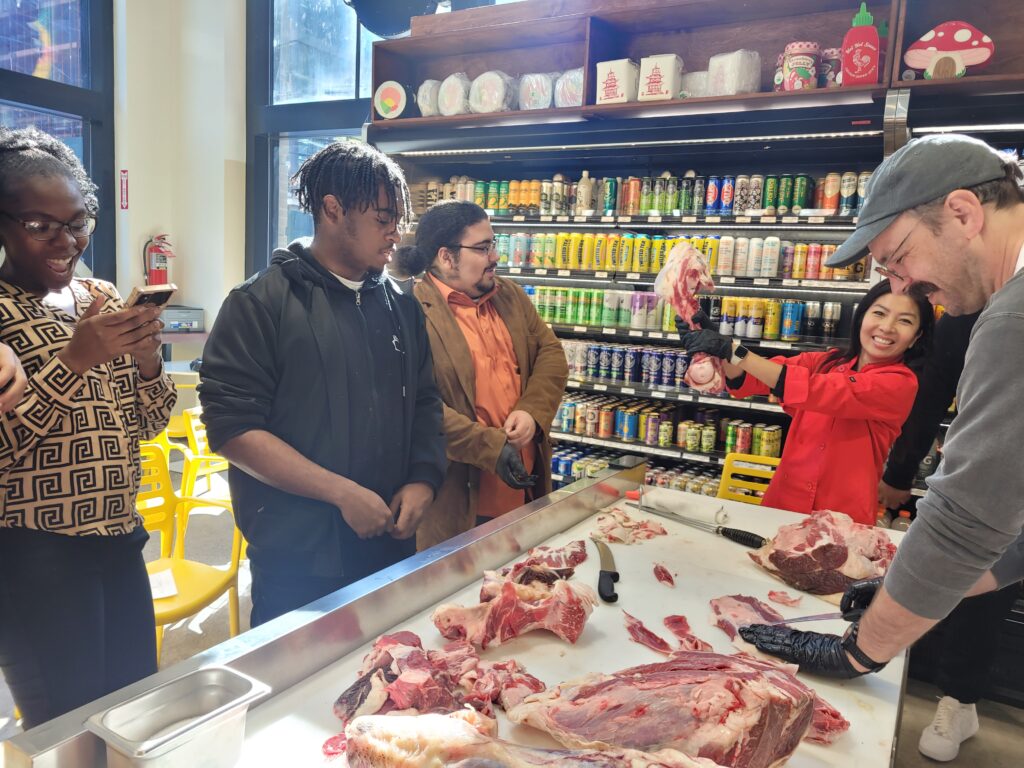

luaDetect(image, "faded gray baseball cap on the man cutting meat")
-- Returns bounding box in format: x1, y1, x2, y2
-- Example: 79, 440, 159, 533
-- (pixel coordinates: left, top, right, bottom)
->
825, 133, 1007, 266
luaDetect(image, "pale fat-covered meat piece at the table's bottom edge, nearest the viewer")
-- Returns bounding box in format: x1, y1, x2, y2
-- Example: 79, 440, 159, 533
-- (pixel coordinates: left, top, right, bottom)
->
345, 711, 715, 768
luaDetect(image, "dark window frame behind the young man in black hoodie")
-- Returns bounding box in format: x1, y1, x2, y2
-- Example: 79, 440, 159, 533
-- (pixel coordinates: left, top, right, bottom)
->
245, 0, 372, 278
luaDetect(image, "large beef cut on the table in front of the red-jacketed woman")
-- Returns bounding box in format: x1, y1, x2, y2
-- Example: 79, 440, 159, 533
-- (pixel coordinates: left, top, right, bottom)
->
748, 511, 896, 595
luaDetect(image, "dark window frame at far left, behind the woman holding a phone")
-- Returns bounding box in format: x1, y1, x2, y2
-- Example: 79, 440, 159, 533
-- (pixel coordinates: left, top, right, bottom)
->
0, 0, 120, 283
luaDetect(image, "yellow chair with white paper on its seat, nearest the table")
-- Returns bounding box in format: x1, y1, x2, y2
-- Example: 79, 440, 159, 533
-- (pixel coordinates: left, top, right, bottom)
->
136, 444, 242, 660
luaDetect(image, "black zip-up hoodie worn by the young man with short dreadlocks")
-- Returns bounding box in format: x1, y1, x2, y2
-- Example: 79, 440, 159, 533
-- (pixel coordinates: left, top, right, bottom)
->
199, 240, 447, 578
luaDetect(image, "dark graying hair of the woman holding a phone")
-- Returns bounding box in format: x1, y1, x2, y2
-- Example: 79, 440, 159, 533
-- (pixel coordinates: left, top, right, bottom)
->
0, 127, 99, 216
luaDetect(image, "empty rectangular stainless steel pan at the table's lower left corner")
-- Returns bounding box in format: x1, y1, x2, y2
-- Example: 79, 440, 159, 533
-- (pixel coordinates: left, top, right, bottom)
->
86, 667, 270, 768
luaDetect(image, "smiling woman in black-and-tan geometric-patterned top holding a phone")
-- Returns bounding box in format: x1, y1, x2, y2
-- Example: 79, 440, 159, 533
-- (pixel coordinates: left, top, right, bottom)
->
0, 129, 175, 728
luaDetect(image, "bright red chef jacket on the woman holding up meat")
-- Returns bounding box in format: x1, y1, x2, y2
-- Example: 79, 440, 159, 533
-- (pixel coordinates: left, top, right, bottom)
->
730, 352, 918, 525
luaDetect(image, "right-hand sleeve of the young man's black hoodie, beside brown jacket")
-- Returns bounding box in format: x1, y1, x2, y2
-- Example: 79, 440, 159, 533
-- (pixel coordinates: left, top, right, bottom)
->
406, 301, 447, 493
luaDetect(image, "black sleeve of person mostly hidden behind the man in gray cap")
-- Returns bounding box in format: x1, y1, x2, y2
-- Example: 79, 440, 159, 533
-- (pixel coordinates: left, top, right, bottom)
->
882, 314, 978, 490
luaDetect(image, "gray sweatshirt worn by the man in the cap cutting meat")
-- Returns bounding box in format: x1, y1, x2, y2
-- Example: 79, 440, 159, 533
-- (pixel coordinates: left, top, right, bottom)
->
886, 270, 1024, 620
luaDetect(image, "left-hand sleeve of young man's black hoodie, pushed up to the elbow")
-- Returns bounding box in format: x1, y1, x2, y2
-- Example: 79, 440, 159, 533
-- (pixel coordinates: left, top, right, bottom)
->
193, 289, 278, 452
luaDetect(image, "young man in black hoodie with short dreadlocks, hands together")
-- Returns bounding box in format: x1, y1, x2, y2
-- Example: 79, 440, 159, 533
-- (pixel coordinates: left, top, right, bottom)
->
199, 142, 446, 627
